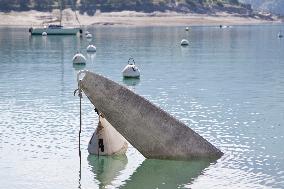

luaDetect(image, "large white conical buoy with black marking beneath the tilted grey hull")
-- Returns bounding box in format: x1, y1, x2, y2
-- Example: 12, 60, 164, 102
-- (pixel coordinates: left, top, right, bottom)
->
88, 114, 128, 156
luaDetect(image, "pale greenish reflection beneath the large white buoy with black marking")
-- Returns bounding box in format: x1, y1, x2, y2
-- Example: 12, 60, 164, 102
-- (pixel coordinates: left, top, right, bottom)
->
87, 155, 128, 188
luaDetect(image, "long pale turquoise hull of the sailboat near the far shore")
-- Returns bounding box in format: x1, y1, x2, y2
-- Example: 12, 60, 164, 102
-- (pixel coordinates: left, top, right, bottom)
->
31, 28, 80, 35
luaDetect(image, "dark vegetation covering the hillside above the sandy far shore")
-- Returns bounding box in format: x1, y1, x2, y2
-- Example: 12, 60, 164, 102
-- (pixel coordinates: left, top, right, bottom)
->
0, 0, 252, 15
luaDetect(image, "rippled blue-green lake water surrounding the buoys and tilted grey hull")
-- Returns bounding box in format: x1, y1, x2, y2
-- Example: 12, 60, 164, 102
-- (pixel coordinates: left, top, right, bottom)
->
0, 25, 284, 189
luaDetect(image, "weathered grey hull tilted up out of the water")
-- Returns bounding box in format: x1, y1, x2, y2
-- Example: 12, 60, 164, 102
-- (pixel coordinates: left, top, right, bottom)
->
78, 71, 223, 159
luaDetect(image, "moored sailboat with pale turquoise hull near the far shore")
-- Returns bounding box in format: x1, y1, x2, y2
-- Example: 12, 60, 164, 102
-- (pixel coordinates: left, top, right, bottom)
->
29, 25, 82, 35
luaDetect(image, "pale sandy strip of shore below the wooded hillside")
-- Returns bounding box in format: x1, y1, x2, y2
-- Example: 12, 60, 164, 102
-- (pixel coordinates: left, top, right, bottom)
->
0, 9, 280, 26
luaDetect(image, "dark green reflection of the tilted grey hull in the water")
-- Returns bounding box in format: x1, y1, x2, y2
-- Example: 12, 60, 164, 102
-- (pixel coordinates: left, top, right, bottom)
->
121, 159, 214, 188
